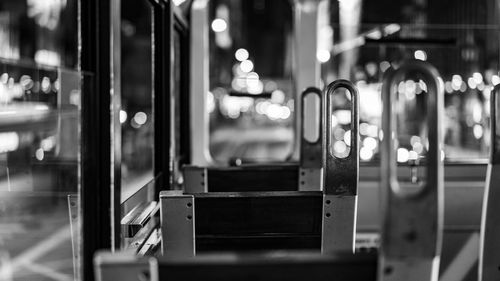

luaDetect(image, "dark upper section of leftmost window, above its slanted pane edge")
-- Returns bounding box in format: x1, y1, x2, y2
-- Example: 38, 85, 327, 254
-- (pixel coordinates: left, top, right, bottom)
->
0, 0, 78, 68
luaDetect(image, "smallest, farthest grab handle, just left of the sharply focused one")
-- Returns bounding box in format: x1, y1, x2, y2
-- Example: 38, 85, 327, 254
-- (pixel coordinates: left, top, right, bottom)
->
300, 87, 323, 168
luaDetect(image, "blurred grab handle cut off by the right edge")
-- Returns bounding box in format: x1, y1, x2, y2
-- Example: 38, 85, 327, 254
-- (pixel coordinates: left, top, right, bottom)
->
478, 85, 500, 281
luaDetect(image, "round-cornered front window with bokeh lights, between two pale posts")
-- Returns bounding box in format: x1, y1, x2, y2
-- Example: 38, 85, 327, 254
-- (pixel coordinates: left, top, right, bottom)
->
207, 0, 294, 164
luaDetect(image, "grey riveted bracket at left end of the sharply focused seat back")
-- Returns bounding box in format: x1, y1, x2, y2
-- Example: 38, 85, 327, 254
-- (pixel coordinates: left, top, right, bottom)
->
160, 190, 196, 257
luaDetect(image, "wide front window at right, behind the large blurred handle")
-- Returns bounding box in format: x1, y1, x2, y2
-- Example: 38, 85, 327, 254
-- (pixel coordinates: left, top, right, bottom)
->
319, 0, 500, 161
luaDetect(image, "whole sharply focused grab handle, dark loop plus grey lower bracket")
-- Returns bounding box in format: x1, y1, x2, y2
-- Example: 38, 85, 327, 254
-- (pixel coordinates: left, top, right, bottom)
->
321, 80, 359, 253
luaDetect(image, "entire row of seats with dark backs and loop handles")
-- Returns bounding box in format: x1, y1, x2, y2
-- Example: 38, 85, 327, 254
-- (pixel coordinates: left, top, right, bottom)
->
96, 61, 500, 281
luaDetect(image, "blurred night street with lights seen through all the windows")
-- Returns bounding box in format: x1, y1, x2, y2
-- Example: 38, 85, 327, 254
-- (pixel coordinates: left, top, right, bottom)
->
0, 0, 500, 280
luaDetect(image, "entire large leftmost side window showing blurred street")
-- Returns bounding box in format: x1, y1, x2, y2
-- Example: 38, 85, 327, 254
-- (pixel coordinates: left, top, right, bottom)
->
0, 0, 83, 280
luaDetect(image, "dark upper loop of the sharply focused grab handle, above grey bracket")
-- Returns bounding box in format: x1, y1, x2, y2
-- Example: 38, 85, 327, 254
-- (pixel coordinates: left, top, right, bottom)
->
323, 77, 359, 196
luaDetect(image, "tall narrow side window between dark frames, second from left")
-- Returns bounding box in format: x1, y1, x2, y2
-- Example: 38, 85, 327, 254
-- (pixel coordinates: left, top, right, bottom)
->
119, 0, 156, 251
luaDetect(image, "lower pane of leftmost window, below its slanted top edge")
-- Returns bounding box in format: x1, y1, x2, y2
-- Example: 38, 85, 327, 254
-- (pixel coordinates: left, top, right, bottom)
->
0, 60, 84, 280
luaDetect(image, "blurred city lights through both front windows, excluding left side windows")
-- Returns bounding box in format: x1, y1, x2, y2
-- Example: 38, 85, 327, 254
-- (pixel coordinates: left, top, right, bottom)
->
208, 0, 500, 162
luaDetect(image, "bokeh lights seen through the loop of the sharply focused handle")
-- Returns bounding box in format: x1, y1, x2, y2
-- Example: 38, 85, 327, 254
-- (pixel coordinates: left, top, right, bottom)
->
327, 88, 352, 158
